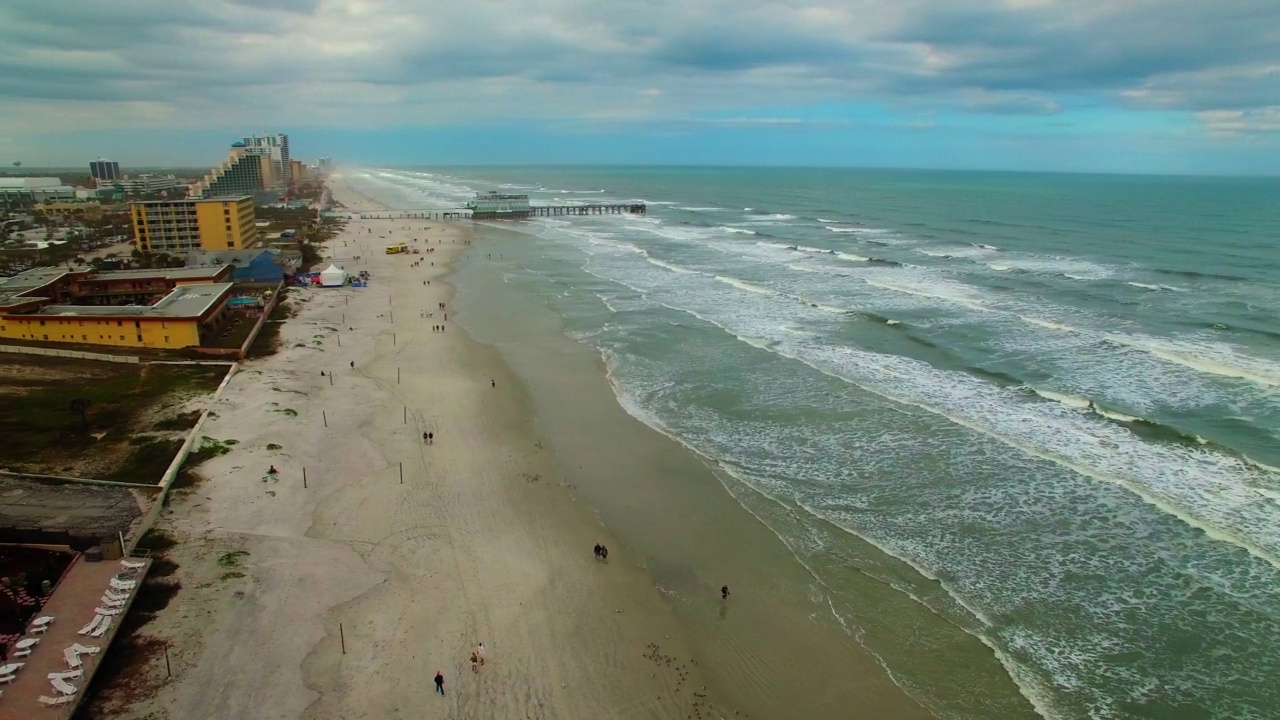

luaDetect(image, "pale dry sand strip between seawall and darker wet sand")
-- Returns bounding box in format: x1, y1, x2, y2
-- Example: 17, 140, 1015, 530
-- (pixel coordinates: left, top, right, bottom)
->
111, 182, 732, 719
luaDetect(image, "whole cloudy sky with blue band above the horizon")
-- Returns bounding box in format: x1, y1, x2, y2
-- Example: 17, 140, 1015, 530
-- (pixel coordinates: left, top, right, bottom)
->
0, 0, 1280, 174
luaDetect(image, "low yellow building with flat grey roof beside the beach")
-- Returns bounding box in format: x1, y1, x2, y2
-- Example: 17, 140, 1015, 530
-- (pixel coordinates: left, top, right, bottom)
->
0, 283, 232, 350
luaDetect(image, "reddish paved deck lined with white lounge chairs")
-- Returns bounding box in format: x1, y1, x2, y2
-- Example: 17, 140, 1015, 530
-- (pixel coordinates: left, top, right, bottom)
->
0, 556, 151, 720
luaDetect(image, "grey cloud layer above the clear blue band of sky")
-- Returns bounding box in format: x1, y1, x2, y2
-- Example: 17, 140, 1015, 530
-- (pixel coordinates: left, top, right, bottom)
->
0, 0, 1280, 133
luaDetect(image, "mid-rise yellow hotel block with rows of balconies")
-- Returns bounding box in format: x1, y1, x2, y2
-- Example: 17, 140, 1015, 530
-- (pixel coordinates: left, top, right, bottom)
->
129, 195, 257, 255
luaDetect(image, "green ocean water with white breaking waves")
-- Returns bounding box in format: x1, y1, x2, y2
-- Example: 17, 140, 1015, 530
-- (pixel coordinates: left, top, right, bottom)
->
344, 168, 1280, 720
